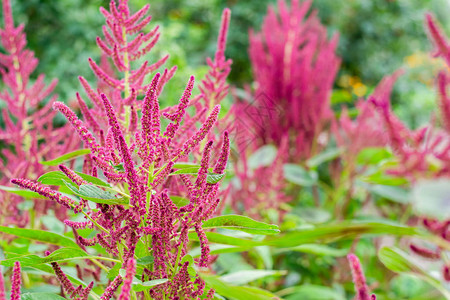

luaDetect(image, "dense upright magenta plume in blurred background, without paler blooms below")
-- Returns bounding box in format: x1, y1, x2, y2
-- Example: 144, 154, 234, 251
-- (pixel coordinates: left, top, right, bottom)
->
239, 0, 340, 160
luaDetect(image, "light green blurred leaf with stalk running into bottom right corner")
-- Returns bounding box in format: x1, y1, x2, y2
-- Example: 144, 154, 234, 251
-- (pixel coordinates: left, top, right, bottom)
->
378, 247, 450, 299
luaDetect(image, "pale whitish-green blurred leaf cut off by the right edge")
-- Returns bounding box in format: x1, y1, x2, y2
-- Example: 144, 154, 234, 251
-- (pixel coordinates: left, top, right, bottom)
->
411, 179, 450, 220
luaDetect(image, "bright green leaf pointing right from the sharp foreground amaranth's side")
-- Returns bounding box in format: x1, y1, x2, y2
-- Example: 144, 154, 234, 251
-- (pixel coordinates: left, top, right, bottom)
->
202, 215, 280, 235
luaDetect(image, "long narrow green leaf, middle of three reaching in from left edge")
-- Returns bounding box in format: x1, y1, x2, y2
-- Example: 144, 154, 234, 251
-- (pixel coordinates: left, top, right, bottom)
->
0, 226, 78, 247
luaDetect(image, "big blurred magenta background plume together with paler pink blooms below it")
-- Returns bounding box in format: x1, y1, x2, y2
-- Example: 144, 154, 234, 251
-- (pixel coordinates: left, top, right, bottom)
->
231, 0, 340, 216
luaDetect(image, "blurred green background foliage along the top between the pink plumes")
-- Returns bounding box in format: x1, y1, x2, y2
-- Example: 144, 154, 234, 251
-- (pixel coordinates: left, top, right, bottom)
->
2, 0, 450, 127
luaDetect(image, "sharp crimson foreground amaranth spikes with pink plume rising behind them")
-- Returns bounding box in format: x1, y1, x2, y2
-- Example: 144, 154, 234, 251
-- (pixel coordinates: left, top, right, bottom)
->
12, 0, 231, 299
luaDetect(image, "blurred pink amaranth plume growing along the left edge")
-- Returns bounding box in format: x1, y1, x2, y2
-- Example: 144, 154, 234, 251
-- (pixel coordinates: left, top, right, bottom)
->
0, 0, 79, 226
